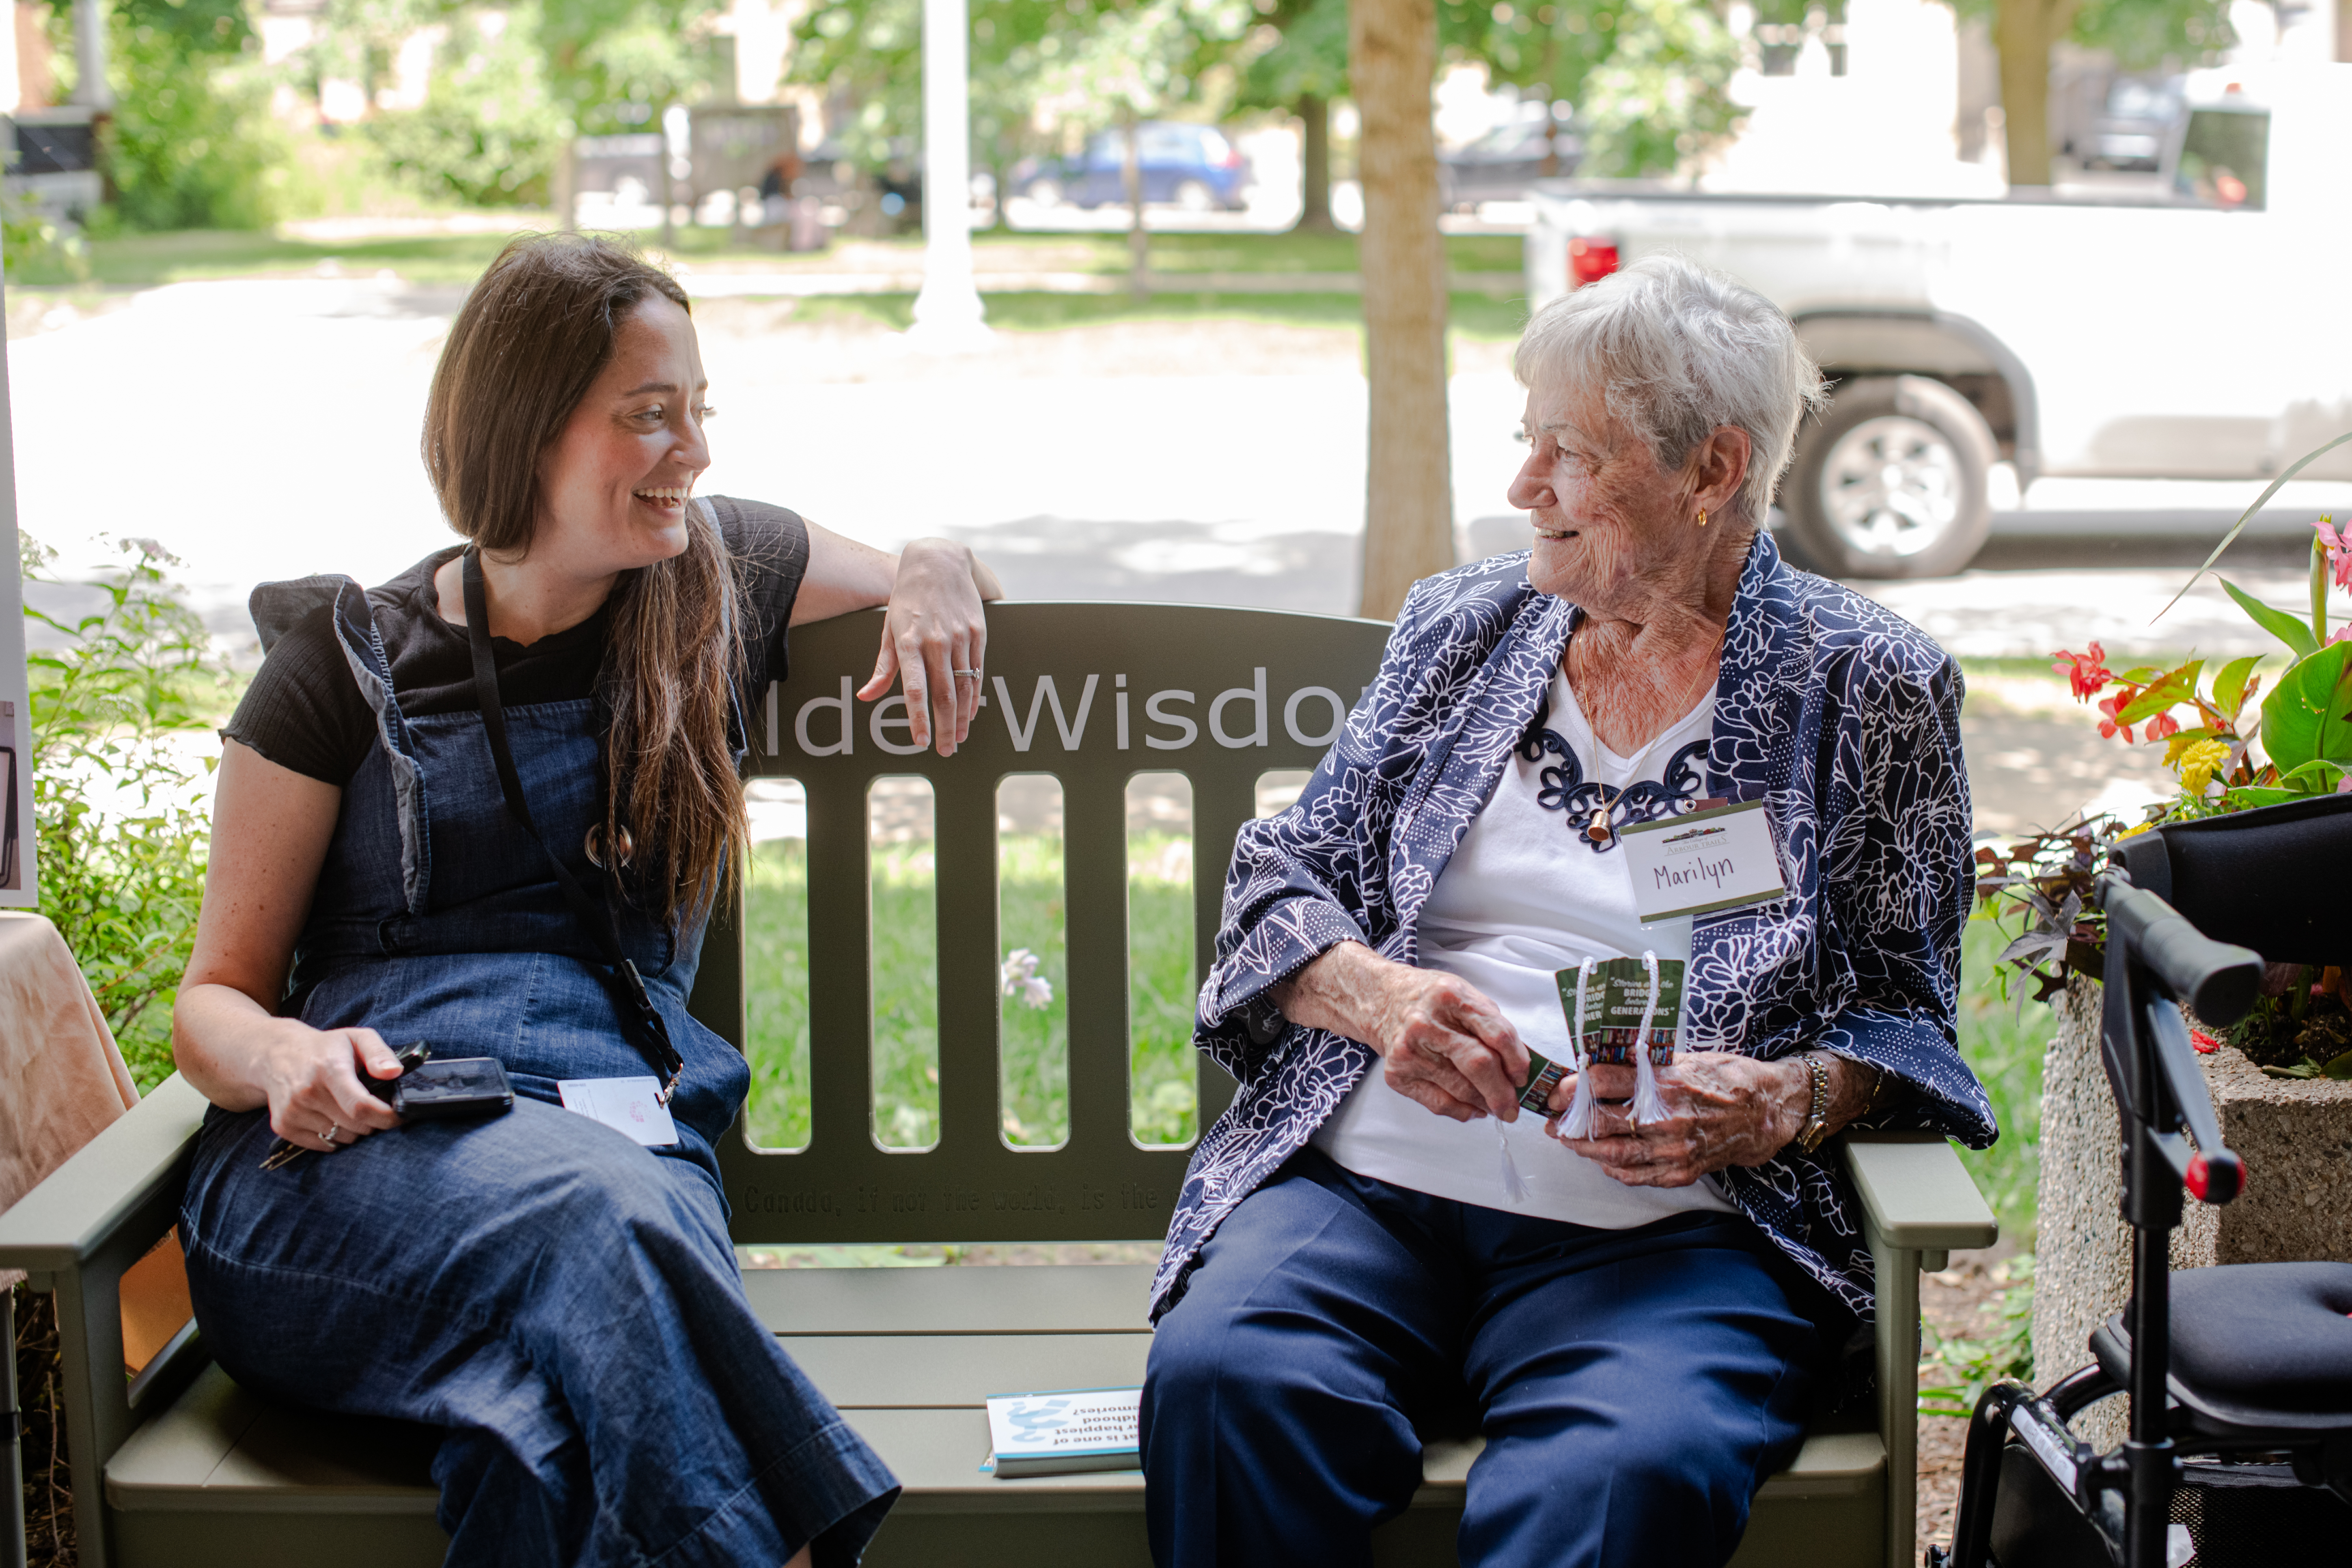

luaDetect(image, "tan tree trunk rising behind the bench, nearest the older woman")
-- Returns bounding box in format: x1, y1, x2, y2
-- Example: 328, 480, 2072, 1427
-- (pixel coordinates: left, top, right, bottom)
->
1348, 0, 1453, 621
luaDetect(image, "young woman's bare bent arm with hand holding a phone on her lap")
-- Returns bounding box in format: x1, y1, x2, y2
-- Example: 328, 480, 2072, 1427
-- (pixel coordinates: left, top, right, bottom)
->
172, 740, 400, 1150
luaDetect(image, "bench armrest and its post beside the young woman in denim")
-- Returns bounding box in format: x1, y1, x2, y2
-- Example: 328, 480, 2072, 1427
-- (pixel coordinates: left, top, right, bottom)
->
0, 1074, 205, 1563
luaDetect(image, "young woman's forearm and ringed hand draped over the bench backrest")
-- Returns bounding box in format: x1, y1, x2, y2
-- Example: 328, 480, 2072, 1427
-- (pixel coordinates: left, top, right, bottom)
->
793, 522, 1004, 757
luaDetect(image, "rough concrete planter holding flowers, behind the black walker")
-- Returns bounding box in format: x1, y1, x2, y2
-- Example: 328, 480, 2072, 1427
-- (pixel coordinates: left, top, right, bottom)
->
2035, 980, 2352, 1448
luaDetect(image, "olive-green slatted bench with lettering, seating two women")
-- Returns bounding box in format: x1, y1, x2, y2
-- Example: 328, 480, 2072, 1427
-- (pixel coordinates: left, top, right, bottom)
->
0, 604, 1994, 1568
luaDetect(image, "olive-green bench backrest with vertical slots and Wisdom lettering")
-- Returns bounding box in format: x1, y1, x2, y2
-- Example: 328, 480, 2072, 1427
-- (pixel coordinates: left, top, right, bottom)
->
694, 604, 1388, 1244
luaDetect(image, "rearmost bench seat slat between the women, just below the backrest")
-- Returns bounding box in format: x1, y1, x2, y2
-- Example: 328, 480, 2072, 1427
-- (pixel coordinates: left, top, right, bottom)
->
743, 1262, 1153, 1335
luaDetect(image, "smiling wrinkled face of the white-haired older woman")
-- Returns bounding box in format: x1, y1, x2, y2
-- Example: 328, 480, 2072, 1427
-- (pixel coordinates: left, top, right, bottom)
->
1510, 386, 1705, 611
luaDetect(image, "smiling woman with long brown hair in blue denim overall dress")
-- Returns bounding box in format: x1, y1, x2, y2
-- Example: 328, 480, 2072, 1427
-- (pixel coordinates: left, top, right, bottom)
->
174, 237, 1000, 1568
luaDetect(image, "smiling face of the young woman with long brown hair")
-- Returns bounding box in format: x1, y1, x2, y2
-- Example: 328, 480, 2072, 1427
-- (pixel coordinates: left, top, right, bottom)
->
532, 294, 710, 576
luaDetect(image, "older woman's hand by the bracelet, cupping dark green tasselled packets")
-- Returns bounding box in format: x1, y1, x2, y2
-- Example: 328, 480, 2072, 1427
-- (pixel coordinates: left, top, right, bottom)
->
1545, 1051, 1813, 1187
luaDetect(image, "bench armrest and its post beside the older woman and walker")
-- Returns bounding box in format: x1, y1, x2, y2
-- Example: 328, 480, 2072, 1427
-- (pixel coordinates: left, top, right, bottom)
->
1846, 1133, 2002, 1568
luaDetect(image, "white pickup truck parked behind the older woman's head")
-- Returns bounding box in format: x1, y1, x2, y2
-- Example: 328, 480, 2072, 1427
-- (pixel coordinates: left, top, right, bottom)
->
1526, 66, 2352, 578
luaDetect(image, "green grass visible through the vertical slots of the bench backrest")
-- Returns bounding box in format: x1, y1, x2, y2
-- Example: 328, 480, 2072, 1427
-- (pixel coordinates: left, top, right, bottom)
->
743, 832, 1197, 1150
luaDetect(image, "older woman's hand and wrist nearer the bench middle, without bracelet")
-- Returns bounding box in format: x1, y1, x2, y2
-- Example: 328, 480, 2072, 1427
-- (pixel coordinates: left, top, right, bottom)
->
1272, 943, 1526, 1122
